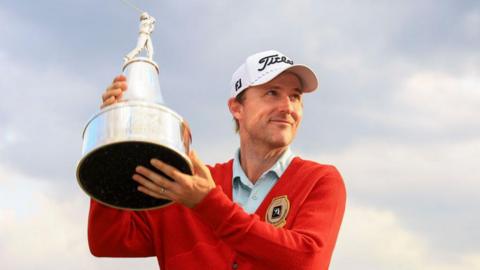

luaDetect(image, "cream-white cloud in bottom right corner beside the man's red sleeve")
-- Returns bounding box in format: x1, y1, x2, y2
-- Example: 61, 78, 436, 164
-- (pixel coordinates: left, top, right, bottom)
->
331, 203, 480, 270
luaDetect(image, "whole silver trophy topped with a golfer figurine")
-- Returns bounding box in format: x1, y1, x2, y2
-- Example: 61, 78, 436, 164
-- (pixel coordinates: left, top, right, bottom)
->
77, 12, 192, 210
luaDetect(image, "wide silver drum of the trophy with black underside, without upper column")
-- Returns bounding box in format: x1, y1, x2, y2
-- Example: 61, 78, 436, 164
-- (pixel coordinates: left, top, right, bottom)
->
77, 101, 192, 210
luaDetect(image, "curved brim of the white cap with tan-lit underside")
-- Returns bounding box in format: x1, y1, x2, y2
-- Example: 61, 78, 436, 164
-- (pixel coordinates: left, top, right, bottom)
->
252, 65, 318, 93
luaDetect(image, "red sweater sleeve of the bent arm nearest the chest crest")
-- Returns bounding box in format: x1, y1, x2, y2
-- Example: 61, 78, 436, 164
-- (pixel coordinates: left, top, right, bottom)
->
190, 167, 346, 269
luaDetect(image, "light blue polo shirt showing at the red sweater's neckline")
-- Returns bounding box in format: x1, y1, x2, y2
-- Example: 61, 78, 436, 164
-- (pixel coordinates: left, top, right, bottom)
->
232, 148, 294, 214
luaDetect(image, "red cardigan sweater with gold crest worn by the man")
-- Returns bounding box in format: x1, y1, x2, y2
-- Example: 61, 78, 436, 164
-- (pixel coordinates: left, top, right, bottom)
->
88, 157, 345, 270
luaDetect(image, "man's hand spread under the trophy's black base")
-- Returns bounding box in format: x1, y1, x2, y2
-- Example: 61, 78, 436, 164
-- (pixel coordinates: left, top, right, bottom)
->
132, 151, 215, 208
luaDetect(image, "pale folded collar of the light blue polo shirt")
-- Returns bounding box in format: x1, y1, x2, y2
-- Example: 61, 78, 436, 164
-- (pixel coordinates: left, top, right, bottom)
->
233, 147, 294, 188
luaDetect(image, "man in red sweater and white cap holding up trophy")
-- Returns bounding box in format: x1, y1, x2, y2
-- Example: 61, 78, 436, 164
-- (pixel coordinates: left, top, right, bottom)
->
89, 51, 345, 270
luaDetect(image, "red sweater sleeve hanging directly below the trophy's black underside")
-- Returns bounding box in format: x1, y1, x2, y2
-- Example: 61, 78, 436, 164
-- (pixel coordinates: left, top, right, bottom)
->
88, 200, 155, 257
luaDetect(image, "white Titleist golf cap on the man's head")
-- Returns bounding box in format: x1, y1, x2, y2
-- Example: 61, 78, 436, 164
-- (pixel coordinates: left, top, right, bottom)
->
231, 50, 318, 97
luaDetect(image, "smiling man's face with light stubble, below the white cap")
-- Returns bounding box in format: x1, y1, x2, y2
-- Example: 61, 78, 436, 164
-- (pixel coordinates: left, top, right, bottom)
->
230, 72, 303, 149
